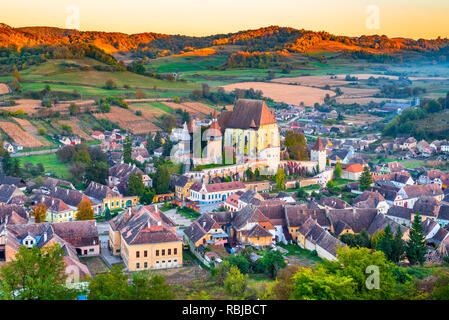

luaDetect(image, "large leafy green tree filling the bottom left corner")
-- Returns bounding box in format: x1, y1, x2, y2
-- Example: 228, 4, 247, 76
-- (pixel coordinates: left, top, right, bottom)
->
0, 244, 77, 300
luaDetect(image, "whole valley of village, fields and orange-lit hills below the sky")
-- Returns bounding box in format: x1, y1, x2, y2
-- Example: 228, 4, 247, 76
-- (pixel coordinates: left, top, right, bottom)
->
0, 23, 449, 300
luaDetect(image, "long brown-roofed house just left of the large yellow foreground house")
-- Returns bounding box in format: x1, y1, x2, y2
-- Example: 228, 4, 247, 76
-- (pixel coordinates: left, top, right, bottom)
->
53, 220, 100, 256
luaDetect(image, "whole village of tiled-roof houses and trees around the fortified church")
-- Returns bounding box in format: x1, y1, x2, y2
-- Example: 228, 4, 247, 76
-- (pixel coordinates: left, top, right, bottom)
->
0, 95, 449, 290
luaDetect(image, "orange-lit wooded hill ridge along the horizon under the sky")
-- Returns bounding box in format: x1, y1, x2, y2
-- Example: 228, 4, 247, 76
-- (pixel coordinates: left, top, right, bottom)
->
0, 24, 449, 54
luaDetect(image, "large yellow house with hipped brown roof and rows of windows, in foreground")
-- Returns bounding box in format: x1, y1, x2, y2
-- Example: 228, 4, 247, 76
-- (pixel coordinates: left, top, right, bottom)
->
108, 205, 182, 271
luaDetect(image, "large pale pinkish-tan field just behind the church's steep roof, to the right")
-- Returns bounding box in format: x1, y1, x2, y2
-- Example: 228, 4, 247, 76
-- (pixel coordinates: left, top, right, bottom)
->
219, 82, 335, 106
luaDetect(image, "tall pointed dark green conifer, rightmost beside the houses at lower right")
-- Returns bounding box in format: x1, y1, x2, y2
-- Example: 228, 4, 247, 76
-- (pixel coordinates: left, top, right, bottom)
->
405, 214, 427, 264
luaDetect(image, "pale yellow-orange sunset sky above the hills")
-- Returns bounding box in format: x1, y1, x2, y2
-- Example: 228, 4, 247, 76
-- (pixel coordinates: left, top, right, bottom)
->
0, 0, 449, 39
